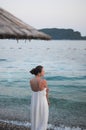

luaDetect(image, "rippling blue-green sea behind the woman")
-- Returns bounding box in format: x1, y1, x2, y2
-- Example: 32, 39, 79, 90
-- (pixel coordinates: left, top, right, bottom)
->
0, 40, 86, 130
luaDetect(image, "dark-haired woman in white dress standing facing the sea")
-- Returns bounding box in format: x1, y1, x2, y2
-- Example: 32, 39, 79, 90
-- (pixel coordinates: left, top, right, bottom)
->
30, 65, 49, 130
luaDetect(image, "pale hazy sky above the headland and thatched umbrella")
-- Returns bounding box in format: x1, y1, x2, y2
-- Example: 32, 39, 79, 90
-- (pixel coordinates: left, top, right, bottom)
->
0, 0, 86, 36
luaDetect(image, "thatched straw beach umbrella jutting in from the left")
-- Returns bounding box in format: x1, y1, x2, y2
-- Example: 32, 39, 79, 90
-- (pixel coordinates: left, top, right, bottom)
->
0, 8, 51, 40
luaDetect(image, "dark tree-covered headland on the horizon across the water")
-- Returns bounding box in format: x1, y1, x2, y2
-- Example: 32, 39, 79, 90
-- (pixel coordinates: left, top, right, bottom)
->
39, 28, 86, 40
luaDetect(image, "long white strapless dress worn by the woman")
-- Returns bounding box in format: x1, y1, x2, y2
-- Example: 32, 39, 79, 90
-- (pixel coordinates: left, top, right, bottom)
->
31, 88, 49, 130
